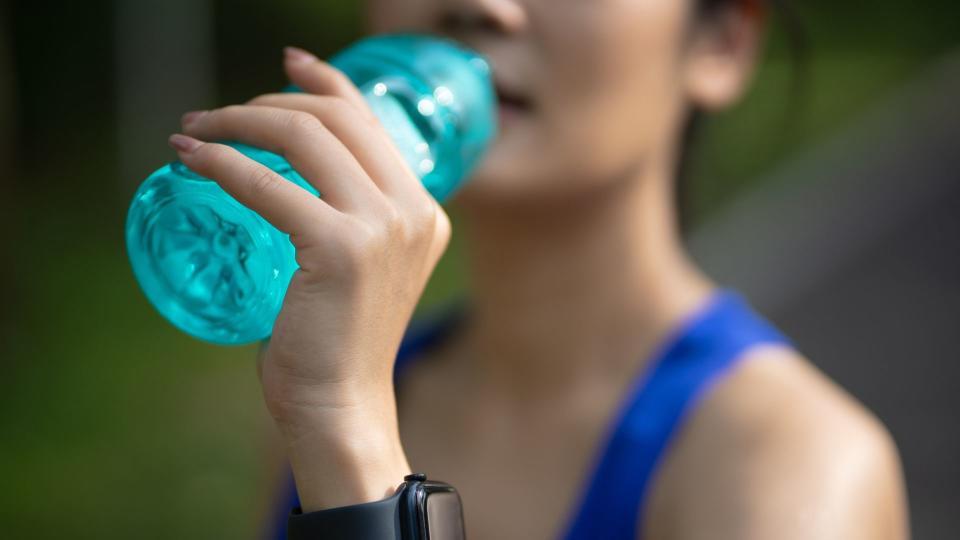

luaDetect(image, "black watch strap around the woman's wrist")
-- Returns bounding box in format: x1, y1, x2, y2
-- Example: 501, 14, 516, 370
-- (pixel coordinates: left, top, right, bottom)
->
287, 488, 403, 540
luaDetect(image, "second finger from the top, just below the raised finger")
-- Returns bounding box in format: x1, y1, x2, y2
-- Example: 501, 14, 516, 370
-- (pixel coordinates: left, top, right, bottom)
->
249, 94, 429, 205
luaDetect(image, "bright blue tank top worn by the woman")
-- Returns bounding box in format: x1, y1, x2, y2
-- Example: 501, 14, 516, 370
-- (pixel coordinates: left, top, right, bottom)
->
271, 290, 788, 540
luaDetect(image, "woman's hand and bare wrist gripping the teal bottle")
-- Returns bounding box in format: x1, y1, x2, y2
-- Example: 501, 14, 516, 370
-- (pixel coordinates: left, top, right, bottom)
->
170, 49, 450, 511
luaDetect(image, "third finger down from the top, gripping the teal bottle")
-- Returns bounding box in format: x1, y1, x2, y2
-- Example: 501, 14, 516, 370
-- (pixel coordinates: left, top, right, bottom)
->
183, 105, 384, 213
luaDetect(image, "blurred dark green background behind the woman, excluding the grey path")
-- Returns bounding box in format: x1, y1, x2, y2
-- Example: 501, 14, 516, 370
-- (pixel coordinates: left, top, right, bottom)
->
0, 0, 960, 539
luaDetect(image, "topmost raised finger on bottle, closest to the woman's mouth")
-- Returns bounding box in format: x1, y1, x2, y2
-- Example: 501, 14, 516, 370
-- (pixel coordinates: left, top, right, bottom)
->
283, 47, 375, 119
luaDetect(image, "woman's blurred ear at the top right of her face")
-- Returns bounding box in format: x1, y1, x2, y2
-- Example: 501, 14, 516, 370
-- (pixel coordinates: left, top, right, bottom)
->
683, 0, 766, 111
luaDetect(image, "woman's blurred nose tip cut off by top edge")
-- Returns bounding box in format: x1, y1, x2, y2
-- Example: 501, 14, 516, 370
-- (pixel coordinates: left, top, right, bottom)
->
439, 0, 527, 38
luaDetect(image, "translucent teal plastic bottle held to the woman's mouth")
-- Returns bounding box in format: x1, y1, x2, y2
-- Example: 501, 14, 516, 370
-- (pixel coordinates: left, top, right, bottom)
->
126, 35, 496, 344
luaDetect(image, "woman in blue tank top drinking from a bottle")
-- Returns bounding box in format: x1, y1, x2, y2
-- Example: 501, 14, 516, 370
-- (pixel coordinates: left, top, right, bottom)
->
171, 0, 908, 540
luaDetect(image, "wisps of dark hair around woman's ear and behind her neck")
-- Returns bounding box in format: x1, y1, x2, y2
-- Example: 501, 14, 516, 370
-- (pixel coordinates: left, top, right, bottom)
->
674, 0, 806, 232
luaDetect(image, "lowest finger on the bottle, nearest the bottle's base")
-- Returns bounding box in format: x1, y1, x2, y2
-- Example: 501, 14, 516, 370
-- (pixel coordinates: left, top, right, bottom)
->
169, 133, 336, 236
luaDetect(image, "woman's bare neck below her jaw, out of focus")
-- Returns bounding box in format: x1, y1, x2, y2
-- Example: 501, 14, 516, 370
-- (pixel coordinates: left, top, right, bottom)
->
454, 162, 711, 399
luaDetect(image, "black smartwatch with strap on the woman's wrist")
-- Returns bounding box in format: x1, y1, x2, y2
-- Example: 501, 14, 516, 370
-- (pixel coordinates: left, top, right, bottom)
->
287, 473, 465, 540
